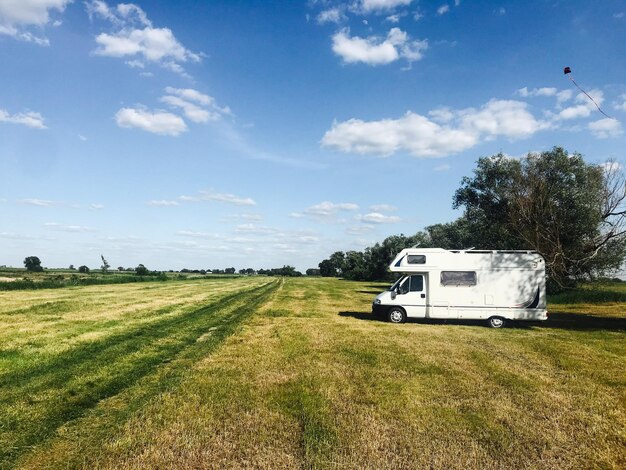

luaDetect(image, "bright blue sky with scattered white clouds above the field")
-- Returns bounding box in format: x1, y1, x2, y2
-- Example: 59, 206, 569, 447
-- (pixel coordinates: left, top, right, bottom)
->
0, 0, 626, 271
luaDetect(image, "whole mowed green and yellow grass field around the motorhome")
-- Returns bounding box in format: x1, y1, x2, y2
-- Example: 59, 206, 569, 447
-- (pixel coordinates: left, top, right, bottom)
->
0, 277, 626, 469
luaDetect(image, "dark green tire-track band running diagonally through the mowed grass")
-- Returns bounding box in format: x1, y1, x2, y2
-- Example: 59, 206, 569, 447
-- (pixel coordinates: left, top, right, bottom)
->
0, 282, 277, 468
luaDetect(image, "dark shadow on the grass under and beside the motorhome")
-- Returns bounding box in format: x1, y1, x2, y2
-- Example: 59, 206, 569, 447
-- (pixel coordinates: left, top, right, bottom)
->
339, 312, 626, 331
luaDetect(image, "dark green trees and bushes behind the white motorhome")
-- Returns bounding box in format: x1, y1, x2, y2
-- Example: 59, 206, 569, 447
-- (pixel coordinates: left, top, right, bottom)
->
319, 147, 626, 290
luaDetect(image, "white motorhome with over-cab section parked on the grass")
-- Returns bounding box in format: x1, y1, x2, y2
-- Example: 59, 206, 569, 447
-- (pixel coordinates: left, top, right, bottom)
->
372, 248, 548, 328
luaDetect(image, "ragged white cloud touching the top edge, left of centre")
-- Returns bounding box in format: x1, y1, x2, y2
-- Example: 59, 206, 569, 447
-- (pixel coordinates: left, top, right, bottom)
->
87, 1, 200, 75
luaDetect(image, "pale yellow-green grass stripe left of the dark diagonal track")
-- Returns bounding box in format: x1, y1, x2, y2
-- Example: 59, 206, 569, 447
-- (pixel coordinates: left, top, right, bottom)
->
0, 280, 251, 356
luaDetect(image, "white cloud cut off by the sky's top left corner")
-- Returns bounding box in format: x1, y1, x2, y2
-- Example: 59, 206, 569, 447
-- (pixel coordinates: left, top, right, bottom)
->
0, 0, 72, 46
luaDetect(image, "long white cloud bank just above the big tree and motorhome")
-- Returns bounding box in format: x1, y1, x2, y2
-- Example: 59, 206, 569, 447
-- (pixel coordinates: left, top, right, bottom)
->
322, 100, 548, 157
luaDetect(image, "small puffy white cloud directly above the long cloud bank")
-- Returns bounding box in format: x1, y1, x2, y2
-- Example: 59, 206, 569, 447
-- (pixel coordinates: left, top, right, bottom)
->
333, 28, 428, 65
